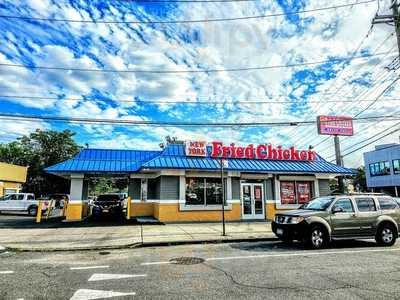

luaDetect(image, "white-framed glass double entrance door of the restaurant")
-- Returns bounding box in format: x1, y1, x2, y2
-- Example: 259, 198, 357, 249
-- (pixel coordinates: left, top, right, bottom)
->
241, 183, 265, 220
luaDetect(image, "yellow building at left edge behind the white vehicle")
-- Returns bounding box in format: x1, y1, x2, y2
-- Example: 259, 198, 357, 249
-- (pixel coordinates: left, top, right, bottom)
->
0, 162, 28, 197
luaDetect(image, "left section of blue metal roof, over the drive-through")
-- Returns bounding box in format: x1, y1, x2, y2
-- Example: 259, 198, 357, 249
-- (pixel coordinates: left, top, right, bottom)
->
46, 149, 161, 173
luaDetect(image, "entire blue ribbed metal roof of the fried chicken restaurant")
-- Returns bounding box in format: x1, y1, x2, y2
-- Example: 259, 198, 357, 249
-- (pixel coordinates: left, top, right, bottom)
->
46, 145, 354, 175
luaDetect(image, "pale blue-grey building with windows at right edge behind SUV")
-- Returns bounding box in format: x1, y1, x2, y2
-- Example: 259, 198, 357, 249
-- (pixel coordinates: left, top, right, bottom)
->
364, 144, 400, 197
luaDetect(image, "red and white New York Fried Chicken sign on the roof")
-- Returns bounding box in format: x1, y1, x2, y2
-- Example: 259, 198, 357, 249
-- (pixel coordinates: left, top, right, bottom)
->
186, 141, 317, 161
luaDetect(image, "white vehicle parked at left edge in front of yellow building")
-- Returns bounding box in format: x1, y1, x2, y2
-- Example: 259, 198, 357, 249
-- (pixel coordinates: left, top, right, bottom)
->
0, 193, 47, 216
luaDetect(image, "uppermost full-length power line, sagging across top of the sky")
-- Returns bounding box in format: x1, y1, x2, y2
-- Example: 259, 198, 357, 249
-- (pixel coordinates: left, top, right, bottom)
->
0, 0, 375, 24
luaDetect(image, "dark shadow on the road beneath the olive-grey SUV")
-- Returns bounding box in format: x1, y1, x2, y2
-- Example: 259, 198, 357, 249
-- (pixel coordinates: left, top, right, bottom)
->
230, 240, 378, 252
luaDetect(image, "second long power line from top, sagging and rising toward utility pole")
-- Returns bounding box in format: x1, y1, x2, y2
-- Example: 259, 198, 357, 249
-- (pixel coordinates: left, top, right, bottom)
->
0, 51, 391, 74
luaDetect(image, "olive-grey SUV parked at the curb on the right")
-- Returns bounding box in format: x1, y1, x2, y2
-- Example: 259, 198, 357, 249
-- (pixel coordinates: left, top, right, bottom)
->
272, 194, 400, 248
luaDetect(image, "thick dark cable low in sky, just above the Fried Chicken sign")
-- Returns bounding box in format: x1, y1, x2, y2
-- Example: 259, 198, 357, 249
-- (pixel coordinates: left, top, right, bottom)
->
0, 113, 400, 127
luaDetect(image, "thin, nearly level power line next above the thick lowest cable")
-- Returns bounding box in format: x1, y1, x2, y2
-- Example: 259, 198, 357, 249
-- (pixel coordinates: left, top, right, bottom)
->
0, 94, 400, 105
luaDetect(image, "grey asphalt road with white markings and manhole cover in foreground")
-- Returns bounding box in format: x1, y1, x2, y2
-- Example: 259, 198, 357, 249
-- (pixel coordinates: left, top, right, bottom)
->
0, 241, 400, 300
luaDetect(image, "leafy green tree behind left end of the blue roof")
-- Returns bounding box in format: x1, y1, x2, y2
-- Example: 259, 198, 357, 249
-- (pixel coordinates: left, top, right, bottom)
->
0, 129, 81, 196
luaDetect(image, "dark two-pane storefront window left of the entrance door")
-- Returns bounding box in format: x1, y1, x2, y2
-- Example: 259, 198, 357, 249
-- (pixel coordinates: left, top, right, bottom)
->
186, 178, 222, 205
